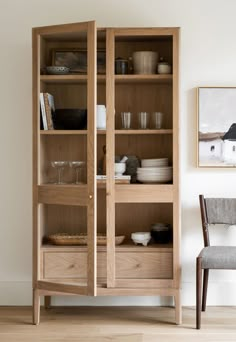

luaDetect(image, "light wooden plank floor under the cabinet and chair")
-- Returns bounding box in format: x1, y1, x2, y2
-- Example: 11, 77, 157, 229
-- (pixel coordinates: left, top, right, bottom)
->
0, 307, 236, 342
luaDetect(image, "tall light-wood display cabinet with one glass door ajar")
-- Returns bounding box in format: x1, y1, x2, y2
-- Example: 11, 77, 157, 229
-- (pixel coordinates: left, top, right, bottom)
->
33, 22, 181, 324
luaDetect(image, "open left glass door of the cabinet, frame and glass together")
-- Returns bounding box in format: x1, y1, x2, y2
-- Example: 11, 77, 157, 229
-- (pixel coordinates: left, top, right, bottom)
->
33, 22, 97, 295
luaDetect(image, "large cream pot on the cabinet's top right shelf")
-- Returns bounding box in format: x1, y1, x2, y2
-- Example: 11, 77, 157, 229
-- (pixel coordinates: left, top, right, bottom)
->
133, 51, 158, 74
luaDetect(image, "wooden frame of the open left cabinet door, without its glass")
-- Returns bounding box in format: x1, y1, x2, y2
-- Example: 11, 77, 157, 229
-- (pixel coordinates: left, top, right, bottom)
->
33, 21, 97, 296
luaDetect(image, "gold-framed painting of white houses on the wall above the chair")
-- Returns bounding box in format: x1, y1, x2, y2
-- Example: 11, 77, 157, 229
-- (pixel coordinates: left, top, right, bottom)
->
197, 87, 236, 167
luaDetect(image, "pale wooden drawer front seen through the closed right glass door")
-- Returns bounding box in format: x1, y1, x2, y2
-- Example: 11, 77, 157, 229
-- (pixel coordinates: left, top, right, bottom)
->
116, 252, 173, 279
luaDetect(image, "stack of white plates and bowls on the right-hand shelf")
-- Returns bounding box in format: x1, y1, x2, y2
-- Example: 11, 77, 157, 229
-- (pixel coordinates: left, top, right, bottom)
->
137, 158, 173, 184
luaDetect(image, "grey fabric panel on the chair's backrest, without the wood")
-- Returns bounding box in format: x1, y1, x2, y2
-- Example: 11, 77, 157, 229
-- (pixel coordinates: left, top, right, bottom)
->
205, 198, 236, 225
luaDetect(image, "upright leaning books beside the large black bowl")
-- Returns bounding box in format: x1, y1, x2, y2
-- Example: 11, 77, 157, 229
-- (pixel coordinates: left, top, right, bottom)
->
40, 93, 55, 130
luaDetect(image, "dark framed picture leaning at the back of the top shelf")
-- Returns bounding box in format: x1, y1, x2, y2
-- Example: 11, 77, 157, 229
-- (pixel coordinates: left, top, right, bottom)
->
52, 49, 106, 74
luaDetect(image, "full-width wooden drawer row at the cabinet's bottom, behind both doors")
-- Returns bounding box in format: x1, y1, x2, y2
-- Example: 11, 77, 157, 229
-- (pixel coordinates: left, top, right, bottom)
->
41, 251, 173, 279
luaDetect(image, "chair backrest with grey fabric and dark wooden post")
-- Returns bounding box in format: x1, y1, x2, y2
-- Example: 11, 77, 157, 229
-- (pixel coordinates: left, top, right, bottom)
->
199, 195, 236, 247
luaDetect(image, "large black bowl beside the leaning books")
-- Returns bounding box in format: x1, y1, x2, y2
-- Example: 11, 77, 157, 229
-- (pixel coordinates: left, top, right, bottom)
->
52, 108, 87, 130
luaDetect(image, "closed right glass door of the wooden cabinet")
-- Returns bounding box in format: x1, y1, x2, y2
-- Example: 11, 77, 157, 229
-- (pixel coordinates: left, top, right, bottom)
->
106, 28, 179, 288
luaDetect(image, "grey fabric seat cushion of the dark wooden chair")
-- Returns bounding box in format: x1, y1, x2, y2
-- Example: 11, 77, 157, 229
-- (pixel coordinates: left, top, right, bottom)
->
199, 246, 236, 270
